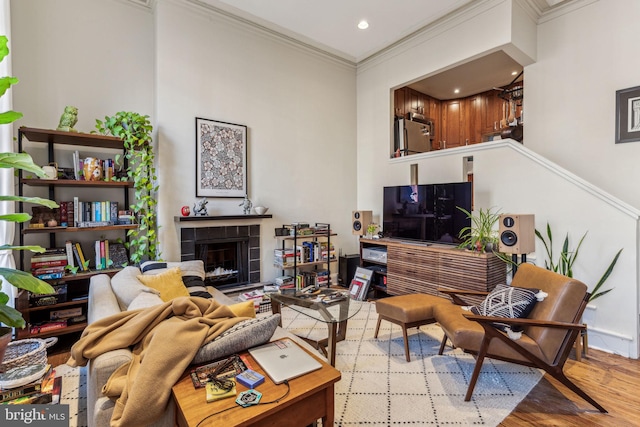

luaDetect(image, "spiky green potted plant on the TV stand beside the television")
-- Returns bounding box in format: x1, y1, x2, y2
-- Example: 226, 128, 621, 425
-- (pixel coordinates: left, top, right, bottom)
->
456, 206, 500, 252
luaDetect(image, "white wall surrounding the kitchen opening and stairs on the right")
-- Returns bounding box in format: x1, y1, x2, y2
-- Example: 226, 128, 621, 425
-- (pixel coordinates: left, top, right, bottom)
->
357, 0, 640, 358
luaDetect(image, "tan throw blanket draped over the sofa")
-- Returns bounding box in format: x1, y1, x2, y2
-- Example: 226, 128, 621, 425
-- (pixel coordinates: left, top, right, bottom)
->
67, 297, 247, 427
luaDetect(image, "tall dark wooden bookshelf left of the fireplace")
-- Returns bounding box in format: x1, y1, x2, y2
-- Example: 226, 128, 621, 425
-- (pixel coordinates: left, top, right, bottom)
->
16, 126, 137, 339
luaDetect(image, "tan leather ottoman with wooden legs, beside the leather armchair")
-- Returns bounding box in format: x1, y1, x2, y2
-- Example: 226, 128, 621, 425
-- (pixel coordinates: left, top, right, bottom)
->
374, 294, 451, 362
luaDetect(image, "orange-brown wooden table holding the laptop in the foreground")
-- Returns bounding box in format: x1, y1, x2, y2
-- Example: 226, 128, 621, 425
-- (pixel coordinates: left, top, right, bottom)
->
171, 338, 340, 427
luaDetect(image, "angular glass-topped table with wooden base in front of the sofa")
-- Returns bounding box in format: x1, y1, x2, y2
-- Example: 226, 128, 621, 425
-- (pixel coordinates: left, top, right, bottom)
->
270, 289, 362, 366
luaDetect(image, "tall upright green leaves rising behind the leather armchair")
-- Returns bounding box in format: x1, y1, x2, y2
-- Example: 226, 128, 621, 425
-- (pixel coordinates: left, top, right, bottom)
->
535, 222, 622, 301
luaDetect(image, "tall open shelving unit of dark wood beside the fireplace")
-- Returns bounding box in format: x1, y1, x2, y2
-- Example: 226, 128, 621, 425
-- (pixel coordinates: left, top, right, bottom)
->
16, 127, 138, 339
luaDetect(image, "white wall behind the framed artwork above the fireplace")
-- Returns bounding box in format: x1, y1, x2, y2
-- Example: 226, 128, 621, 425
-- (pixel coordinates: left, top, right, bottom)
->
156, 1, 357, 280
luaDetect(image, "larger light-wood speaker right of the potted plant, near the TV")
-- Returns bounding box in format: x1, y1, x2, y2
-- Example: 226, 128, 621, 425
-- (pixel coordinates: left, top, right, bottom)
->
498, 214, 536, 255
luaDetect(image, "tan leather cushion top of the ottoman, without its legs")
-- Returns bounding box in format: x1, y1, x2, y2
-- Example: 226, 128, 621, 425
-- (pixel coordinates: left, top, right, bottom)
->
376, 294, 444, 323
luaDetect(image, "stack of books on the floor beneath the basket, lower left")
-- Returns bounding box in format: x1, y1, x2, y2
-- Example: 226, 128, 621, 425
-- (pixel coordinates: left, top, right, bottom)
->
0, 365, 62, 405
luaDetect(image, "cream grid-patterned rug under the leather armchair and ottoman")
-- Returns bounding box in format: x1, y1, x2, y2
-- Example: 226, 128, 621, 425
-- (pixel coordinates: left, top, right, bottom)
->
282, 303, 543, 426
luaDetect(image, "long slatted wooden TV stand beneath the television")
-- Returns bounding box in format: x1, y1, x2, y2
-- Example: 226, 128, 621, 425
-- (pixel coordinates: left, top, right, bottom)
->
360, 238, 507, 303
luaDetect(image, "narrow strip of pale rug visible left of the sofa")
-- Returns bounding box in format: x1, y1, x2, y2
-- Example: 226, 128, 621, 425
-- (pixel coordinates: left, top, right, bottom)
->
55, 365, 89, 427
